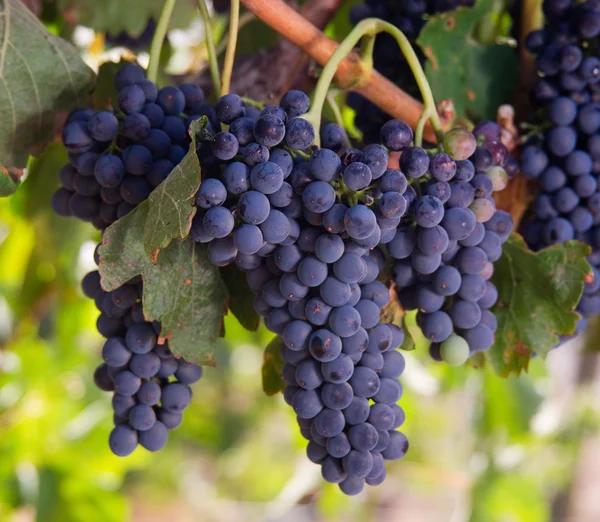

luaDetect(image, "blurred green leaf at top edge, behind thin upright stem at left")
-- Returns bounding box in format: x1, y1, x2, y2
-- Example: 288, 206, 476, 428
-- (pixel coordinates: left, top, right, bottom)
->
57, 0, 196, 37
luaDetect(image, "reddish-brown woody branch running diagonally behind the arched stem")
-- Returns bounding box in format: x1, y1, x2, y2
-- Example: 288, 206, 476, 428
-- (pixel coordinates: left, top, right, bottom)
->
242, 0, 448, 143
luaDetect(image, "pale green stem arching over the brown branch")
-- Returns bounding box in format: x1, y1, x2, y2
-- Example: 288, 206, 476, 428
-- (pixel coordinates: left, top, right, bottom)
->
302, 18, 444, 146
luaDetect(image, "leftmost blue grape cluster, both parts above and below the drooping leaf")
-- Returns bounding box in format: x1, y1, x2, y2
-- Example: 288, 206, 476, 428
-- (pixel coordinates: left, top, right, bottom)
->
52, 65, 204, 456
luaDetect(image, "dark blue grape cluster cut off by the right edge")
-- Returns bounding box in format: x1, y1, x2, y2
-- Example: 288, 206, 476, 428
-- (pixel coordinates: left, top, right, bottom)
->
521, 0, 600, 334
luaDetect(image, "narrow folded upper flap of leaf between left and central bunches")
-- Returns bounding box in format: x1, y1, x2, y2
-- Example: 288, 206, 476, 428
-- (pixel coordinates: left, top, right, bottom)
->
144, 120, 208, 262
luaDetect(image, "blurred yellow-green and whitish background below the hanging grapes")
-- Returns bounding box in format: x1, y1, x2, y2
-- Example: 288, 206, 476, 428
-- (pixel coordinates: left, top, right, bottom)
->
0, 145, 600, 522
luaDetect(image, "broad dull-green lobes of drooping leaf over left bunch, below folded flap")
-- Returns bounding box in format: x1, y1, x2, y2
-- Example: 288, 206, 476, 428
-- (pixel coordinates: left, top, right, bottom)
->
99, 202, 227, 364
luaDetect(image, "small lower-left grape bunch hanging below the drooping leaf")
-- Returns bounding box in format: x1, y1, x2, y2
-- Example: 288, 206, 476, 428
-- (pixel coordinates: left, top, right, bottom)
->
82, 271, 202, 457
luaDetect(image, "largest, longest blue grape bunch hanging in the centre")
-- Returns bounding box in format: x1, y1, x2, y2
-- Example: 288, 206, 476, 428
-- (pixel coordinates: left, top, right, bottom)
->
191, 91, 412, 494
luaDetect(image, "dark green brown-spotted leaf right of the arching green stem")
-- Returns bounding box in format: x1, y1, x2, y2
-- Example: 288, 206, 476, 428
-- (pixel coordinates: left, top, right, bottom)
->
417, 0, 518, 120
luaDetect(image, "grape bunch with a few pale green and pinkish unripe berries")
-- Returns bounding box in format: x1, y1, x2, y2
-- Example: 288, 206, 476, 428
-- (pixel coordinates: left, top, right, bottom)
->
390, 122, 513, 364
